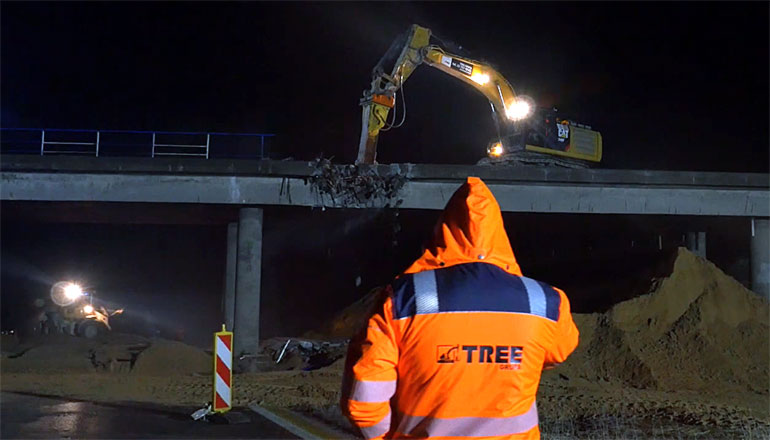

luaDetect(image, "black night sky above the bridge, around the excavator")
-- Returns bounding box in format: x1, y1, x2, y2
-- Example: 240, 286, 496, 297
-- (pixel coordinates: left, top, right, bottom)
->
0, 2, 768, 172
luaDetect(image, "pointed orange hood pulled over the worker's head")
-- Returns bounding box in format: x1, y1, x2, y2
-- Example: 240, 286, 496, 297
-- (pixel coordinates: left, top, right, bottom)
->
404, 177, 521, 276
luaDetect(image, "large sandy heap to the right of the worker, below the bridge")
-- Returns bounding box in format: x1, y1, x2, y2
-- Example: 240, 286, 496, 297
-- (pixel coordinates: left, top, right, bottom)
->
558, 248, 770, 394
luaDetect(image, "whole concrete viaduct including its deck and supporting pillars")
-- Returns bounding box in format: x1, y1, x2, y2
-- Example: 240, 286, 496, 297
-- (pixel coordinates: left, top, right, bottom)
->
0, 155, 770, 351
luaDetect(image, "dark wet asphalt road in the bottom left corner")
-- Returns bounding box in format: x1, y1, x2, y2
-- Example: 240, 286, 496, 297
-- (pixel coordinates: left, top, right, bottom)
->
0, 392, 298, 439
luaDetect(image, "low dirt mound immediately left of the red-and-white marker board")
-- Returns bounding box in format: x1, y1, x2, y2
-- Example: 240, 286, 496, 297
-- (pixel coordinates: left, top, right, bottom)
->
131, 339, 213, 376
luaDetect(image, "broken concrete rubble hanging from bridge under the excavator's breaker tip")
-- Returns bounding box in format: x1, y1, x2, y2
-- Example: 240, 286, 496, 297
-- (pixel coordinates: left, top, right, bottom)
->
307, 159, 406, 207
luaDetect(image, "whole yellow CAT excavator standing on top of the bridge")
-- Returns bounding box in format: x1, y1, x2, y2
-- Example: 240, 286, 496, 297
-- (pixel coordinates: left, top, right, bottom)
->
356, 24, 602, 168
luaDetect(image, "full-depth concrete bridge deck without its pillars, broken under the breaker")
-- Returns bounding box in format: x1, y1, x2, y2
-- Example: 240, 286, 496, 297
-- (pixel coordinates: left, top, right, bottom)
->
0, 156, 770, 217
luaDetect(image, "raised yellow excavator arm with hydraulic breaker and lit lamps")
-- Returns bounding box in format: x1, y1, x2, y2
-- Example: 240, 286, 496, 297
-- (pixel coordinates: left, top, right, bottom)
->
356, 25, 533, 164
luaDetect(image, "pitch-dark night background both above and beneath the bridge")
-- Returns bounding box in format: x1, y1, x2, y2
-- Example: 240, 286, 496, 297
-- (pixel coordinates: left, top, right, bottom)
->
0, 2, 769, 348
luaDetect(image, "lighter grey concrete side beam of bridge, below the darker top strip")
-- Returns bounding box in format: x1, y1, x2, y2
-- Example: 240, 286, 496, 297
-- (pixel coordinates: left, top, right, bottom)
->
0, 172, 770, 217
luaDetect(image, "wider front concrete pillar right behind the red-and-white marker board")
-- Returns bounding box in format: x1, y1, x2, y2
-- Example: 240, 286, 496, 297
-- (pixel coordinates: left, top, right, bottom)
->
228, 208, 263, 356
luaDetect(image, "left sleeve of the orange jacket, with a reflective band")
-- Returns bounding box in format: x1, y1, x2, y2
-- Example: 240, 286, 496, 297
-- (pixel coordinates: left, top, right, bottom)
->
340, 290, 398, 438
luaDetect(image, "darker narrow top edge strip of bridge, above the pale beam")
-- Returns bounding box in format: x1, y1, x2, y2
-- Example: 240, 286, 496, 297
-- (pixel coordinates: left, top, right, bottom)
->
0, 155, 770, 188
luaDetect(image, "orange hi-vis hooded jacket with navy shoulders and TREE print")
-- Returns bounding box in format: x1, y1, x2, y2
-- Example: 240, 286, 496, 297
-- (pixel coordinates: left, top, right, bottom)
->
341, 177, 578, 439
